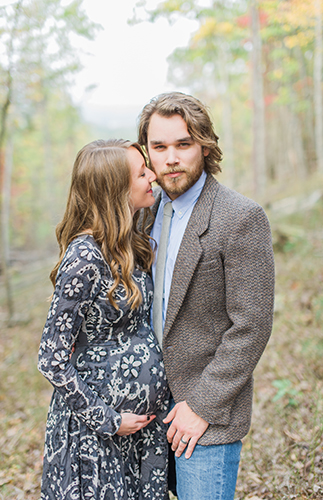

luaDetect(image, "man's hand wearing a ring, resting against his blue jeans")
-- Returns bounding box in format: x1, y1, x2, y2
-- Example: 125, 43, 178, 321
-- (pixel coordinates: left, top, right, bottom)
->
164, 401, 209, 458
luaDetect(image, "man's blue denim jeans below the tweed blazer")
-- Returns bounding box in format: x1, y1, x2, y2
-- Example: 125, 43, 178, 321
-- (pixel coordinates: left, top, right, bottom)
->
175, 441, 242, 500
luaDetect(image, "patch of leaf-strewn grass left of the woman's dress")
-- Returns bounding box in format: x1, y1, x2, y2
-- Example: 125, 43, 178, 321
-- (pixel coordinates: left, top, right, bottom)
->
0, 302, 52, 500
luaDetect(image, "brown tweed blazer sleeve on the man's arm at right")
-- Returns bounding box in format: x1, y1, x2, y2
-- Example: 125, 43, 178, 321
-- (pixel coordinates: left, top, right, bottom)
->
186, 204, 274, 425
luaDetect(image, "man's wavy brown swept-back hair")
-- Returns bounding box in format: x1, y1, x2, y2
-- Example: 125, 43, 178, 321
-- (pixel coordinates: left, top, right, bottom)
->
138, 92, 222, 174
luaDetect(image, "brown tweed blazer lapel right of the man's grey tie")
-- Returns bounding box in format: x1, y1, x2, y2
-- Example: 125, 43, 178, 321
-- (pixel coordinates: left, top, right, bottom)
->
164, 174, 219, 337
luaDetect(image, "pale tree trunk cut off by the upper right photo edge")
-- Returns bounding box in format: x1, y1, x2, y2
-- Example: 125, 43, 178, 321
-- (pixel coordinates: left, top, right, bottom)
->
314, 0, 323, 173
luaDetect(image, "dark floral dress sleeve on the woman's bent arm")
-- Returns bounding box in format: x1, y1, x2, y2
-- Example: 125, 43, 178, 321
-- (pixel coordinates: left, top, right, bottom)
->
38, 240, 121, 439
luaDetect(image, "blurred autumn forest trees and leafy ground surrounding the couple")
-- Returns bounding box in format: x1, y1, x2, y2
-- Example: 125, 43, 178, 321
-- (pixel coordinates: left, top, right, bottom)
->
0, 0, 323, 500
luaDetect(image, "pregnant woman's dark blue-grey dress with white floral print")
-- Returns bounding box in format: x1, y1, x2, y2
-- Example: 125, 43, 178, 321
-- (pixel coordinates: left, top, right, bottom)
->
38, 235, 168, 500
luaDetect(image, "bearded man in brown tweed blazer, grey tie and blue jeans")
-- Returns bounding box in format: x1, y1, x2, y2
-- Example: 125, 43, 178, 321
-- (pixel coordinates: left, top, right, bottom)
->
139, 92, 274, 500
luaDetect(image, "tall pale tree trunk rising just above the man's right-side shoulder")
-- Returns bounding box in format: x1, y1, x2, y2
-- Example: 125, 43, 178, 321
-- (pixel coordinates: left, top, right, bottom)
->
250, 0, 266, 197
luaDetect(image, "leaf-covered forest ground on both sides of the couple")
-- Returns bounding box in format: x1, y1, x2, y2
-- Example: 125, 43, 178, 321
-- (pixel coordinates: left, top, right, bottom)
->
0, 199, 323, 500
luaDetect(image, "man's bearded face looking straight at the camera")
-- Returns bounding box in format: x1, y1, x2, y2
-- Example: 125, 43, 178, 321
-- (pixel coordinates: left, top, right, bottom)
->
147, 113, 209, 200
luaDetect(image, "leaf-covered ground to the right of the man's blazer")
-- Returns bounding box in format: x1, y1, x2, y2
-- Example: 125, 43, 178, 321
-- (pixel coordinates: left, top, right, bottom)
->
236, 202, 323, 500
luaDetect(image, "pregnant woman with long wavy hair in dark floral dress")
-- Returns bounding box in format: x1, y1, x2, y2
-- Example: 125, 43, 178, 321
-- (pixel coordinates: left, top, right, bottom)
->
38, 141, 168, 500
